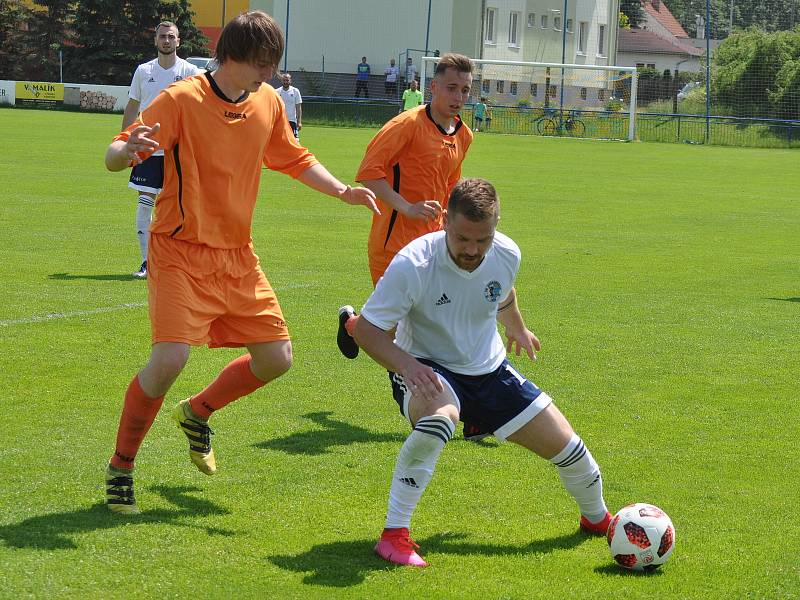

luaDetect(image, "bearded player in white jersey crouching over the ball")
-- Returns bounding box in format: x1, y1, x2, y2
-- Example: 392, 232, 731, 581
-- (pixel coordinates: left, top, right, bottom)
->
355, 179, 611, 567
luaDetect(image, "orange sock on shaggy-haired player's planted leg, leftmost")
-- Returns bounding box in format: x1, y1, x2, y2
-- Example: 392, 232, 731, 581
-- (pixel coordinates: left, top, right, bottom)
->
110, 374, 164, 469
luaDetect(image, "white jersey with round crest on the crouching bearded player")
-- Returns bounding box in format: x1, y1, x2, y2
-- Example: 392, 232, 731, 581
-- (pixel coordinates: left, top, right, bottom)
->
361, 231, 521, 375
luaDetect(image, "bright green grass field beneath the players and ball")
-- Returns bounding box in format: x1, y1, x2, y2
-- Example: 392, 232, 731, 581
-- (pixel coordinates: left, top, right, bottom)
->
0, 109, 800, 599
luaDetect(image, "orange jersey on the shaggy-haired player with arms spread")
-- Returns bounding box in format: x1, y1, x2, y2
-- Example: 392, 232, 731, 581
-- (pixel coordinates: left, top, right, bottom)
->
114, 74, 317, 248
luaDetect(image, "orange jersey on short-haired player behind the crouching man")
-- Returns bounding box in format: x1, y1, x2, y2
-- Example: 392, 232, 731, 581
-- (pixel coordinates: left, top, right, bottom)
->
356, 105, 472, 278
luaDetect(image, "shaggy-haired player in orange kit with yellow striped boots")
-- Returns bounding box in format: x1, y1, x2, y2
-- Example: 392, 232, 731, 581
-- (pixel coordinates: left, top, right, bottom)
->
106, 11, 378, 514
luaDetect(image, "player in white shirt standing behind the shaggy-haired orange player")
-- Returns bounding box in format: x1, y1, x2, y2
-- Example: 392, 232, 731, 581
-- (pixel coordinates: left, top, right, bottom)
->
122, 21, 202, 279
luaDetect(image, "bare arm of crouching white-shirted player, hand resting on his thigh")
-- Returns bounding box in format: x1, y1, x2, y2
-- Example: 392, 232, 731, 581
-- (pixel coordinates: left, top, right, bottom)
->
353, 315, 444, 400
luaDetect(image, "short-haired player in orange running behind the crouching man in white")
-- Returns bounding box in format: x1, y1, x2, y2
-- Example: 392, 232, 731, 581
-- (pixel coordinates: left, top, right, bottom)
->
336, 54, 473, 358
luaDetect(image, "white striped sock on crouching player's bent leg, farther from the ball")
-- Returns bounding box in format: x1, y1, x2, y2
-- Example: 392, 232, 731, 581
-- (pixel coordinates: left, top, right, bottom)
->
386, 415, 456, 529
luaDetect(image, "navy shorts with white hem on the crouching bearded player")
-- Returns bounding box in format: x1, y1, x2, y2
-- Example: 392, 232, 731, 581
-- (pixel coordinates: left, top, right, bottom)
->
389, 359, 552, 441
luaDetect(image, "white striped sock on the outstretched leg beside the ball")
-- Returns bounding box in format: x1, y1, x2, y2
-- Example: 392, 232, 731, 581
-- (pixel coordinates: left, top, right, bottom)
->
550, 433, 608, 523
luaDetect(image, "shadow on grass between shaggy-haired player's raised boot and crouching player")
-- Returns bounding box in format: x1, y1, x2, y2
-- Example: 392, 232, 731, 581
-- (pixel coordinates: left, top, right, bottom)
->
253, 411, 406, 455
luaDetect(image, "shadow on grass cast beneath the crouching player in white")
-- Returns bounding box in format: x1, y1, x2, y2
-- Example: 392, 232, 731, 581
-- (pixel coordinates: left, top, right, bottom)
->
267, 531, 589, 588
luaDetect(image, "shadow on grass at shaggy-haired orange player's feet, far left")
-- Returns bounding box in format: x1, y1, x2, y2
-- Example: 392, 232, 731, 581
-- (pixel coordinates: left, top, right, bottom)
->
0, 485, 235, 550
